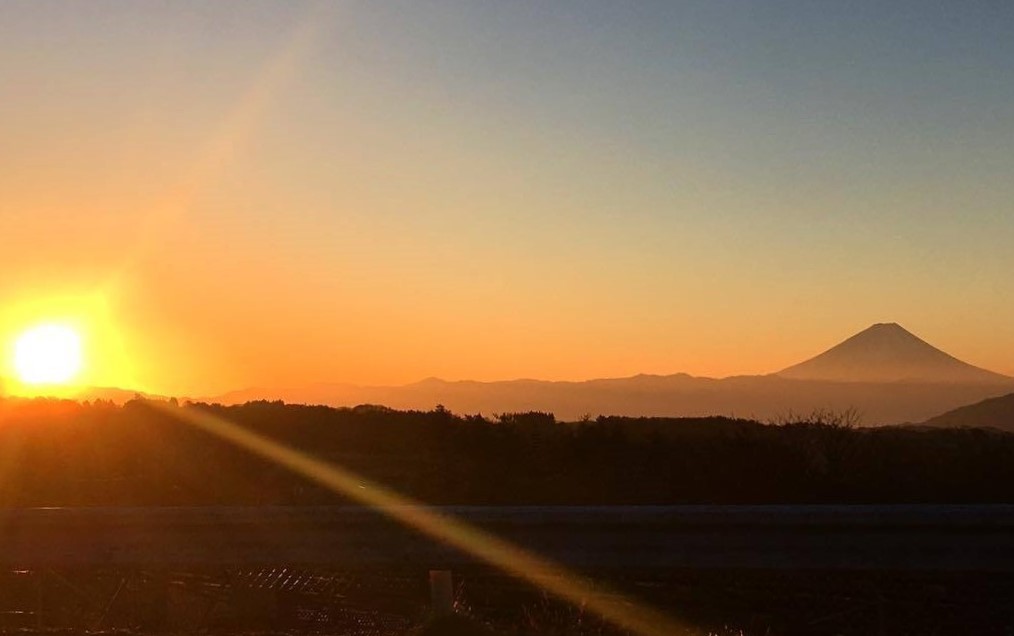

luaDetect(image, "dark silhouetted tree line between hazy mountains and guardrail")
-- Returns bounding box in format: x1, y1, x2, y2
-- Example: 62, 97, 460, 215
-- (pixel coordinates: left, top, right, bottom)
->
0, 400, 1014, 506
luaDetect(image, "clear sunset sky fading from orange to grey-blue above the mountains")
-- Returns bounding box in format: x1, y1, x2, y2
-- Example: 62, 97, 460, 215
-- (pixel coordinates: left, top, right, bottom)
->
0, 0, 1014, 397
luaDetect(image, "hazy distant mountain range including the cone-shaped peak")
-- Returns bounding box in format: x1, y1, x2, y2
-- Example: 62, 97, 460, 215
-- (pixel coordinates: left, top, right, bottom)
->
209, 324, 1014, 425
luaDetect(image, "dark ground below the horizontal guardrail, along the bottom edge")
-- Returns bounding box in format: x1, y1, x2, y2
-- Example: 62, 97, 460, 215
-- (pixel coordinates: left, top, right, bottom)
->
0, 566, 1014, 636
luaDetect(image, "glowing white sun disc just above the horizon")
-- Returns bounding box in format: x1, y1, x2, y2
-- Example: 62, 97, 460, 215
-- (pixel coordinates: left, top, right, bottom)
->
14, 325, 81, 384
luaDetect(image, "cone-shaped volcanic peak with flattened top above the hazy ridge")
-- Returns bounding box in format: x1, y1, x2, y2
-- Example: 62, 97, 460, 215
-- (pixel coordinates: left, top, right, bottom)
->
778, 323, 1014, 384
